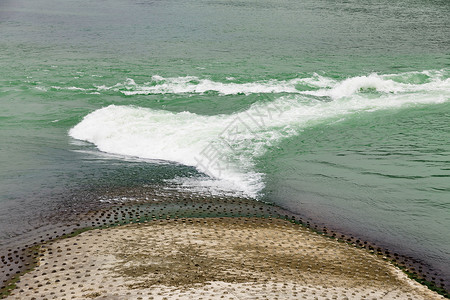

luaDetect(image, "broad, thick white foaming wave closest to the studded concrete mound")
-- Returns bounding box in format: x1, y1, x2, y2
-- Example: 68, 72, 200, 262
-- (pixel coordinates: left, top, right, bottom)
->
69, 75, 450, 197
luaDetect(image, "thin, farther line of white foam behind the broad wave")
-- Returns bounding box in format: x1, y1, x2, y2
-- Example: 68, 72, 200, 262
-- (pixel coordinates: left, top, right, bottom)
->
36, 69, 450, 99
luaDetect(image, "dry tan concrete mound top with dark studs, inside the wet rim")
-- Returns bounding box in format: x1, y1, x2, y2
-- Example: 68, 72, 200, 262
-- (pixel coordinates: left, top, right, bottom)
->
9, 218, 444, 300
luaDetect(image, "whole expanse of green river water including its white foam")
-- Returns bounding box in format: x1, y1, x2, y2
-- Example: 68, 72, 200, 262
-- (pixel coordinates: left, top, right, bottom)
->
0, 0, 450, 284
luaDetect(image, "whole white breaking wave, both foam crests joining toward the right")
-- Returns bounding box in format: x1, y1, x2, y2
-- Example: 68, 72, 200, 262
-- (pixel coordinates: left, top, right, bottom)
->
69, 72, 450, 197
